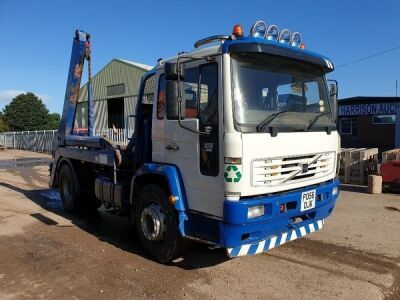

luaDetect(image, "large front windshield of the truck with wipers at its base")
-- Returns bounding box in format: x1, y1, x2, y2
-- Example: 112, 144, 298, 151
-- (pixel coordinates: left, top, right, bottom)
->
232, 53, 333, 128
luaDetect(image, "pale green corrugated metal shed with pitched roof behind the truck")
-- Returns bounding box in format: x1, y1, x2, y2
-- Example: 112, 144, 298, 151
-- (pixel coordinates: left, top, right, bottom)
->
75, 59, 152, 132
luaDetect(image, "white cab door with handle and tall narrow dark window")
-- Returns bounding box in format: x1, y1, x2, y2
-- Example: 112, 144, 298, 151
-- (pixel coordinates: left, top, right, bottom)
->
165, 58, 224, 217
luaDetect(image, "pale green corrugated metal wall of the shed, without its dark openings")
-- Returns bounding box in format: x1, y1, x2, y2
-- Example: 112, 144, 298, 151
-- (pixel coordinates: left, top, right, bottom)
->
75, 59, 147, 130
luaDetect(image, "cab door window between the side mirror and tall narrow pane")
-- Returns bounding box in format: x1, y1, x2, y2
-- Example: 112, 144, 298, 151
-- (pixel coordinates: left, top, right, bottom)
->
184, 67, 199, 118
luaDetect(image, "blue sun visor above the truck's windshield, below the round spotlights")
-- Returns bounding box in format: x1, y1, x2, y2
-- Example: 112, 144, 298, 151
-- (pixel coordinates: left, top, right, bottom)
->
223, 41, 334, 73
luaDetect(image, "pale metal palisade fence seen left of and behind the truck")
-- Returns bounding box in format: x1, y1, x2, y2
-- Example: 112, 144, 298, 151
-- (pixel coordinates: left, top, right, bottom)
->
0, 128, 128, 153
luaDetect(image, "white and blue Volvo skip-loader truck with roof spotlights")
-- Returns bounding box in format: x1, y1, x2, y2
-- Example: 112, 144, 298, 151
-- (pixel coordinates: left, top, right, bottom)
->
50, 21, 340, 262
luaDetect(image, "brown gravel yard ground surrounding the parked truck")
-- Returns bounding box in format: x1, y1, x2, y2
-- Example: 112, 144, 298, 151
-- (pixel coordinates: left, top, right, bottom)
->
0, 151, 400, 299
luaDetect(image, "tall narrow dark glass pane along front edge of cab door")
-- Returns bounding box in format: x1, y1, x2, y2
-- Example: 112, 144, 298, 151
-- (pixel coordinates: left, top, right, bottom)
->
199, 63, 219, 176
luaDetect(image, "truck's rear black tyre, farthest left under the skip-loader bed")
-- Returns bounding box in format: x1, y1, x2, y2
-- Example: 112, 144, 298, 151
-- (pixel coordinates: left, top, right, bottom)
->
59, 164, 78, 213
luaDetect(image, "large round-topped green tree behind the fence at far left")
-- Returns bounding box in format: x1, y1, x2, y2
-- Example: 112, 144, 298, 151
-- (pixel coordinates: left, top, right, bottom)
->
3, 92, 49, 131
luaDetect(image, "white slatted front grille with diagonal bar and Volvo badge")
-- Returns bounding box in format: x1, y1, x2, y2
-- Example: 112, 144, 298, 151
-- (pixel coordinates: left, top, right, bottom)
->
252, 152, 335, 186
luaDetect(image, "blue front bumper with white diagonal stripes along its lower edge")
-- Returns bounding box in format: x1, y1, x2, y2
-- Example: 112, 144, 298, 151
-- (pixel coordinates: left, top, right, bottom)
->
220, 179, 339, 257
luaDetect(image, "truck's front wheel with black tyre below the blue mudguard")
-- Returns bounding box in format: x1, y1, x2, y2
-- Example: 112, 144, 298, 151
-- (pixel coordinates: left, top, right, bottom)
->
135, 184, 184, 263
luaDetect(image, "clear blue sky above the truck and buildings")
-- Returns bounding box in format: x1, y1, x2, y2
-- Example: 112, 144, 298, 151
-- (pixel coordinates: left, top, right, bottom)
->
0, 0, 400, 113
